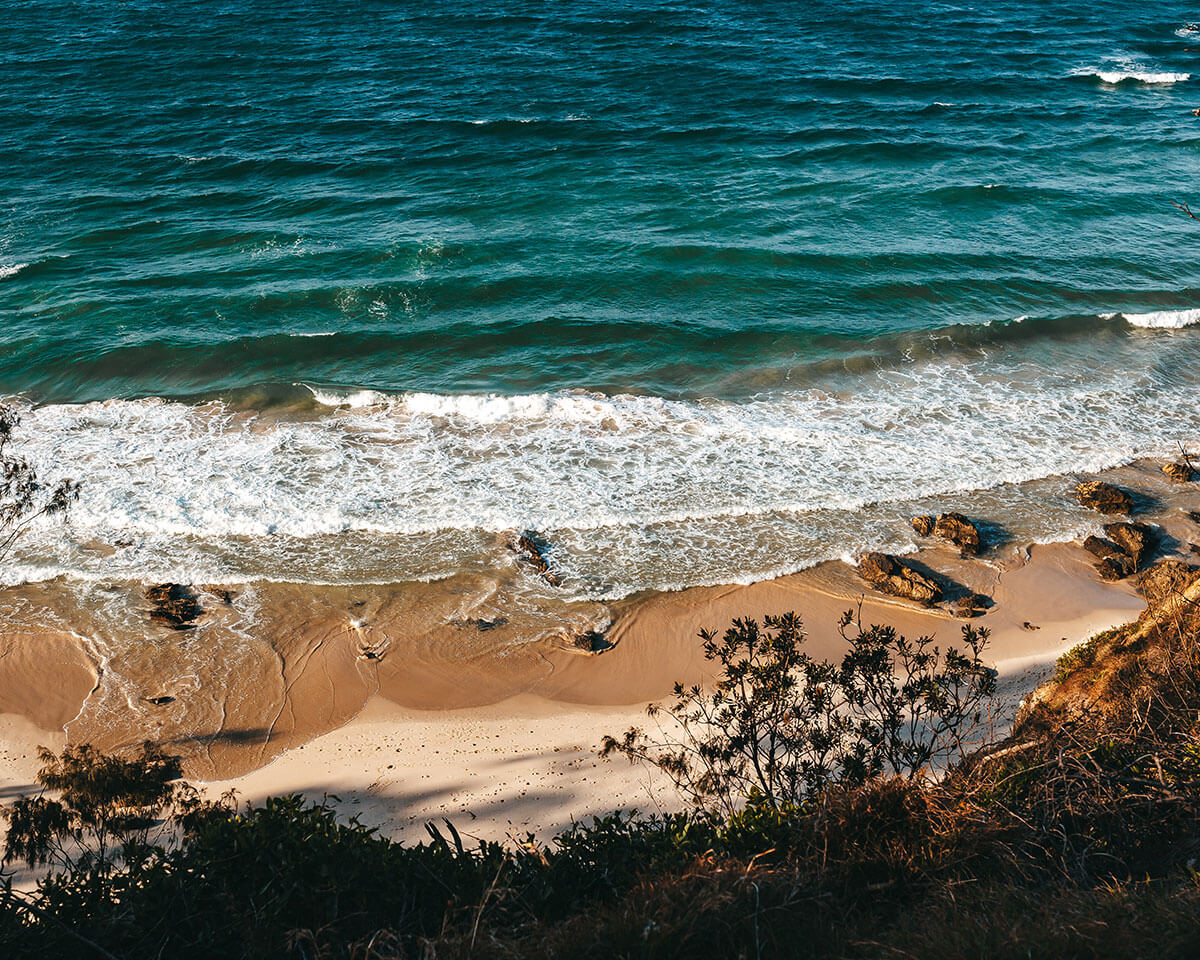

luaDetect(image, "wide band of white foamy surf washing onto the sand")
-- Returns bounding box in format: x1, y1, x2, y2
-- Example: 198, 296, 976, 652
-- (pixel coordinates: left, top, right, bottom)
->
12, 331, 1200, 596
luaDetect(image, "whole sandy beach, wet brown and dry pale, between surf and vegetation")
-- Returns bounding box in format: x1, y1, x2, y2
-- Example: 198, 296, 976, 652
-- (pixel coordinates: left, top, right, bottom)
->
9, 480, 1194, 840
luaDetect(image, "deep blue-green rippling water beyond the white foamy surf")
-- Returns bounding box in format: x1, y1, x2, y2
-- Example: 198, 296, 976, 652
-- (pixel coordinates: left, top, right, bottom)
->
0, 0, 1200, 401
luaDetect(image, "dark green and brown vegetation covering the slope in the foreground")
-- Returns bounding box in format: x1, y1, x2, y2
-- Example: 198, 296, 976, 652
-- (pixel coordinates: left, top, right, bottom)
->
0, 562, 1200, 958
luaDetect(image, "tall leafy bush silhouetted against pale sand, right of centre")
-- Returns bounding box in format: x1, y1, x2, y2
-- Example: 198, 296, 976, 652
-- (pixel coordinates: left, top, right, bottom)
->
602, 611, 995, 816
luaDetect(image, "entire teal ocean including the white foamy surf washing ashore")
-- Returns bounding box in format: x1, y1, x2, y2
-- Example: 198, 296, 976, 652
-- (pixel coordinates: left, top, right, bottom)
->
0, 0, 1200, 608
